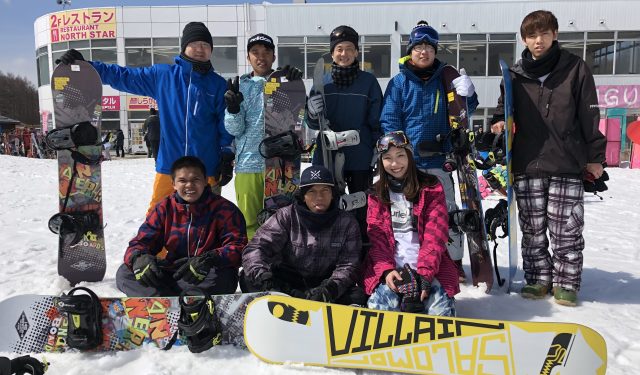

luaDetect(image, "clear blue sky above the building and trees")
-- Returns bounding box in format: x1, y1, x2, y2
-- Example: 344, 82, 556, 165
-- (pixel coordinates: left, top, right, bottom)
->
0, 0, 422, 84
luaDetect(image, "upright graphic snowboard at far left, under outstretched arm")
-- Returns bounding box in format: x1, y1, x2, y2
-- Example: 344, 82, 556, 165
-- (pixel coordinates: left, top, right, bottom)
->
49, 61, 106, 285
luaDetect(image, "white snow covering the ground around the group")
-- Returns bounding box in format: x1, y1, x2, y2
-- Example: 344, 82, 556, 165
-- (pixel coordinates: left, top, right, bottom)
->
0, 155, 640, 375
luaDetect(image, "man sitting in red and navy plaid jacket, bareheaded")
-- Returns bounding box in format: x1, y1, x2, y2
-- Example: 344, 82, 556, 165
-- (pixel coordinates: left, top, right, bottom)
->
116, 156, 247, 297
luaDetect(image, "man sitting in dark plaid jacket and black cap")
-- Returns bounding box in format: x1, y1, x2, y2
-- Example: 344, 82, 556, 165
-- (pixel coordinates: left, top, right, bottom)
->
240, 166, 367, 305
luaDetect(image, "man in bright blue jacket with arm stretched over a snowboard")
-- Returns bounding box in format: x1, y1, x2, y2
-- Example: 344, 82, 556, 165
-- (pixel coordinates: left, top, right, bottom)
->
60, 22, 234, 210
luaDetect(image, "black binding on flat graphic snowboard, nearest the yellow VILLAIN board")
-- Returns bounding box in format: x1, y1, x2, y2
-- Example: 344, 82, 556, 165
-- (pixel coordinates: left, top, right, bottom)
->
178, 288, 222, 353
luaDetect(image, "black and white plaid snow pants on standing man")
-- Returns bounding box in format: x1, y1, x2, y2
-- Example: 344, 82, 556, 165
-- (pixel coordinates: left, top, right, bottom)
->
514, 175, 584, 291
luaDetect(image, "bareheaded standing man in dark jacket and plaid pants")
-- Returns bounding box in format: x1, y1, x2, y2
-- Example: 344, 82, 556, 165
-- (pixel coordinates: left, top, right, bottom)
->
491, 10, 606, 306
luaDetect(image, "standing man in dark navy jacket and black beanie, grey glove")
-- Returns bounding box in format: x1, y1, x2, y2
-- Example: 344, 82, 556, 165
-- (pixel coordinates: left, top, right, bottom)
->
307, 26, 382, 247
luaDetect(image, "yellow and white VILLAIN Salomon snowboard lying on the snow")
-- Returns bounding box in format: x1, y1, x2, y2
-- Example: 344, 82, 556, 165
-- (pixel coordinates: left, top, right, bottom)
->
244, 295, 607, 375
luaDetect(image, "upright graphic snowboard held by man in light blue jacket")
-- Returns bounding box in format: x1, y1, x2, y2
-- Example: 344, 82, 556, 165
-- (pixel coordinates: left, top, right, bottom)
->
259, 70, 306, 223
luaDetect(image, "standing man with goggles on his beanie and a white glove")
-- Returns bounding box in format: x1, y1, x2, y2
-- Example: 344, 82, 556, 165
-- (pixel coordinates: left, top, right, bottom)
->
380, 21, 478, 282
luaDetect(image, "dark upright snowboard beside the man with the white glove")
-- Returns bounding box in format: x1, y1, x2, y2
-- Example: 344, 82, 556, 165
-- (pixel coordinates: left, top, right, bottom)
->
442, 65, 493, 292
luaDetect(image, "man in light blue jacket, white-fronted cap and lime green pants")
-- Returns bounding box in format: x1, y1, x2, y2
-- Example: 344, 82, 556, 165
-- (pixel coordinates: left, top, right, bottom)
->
224, 34, 302, 239
